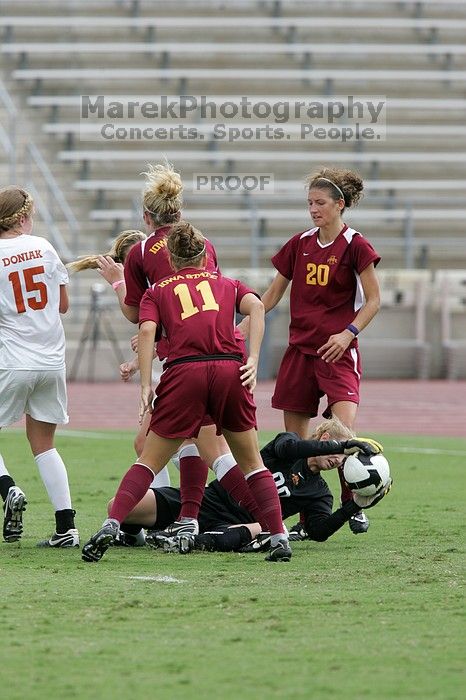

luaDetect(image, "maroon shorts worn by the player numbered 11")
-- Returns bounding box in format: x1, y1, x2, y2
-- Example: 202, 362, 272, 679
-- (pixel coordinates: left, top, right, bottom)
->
149, 360, 256, 438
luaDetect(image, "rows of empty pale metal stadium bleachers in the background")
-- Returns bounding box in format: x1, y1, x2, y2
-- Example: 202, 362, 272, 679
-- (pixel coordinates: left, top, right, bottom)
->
0, 0, 466, 376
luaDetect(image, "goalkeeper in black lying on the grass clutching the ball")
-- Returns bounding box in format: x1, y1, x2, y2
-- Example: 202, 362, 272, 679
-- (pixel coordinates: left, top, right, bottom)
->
112, 418, 388, 553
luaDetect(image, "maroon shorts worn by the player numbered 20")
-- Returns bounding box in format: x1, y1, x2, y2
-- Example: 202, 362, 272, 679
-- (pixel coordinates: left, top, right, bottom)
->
272, 345, 361, 417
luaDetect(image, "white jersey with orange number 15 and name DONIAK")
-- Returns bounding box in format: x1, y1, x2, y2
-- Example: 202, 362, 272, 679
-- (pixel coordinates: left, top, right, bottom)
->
0, 235, 68, 370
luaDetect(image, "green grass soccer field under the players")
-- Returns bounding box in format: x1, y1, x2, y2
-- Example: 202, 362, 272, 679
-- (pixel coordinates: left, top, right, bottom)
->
0, 430, 466, 700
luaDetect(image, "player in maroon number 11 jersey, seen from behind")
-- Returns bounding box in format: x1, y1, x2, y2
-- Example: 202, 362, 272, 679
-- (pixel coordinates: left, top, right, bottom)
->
83, 222, 291, 561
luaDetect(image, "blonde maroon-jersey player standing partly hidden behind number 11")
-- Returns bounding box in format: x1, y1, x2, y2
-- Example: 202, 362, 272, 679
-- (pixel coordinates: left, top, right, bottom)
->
95, 163, 266, 534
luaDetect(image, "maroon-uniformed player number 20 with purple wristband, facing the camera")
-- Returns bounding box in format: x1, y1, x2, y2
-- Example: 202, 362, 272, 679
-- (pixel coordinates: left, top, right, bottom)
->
238, 168, 380, 532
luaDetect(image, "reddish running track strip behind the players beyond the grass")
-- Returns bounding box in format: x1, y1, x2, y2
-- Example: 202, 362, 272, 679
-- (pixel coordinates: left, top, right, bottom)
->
59, 380, 466, 437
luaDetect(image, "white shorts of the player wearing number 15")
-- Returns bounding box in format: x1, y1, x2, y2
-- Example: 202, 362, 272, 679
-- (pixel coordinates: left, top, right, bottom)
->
0, 368, 69, 428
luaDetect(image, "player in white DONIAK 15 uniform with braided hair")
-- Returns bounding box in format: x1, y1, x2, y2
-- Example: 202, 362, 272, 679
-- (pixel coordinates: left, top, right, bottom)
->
0, 187, 79, 547
